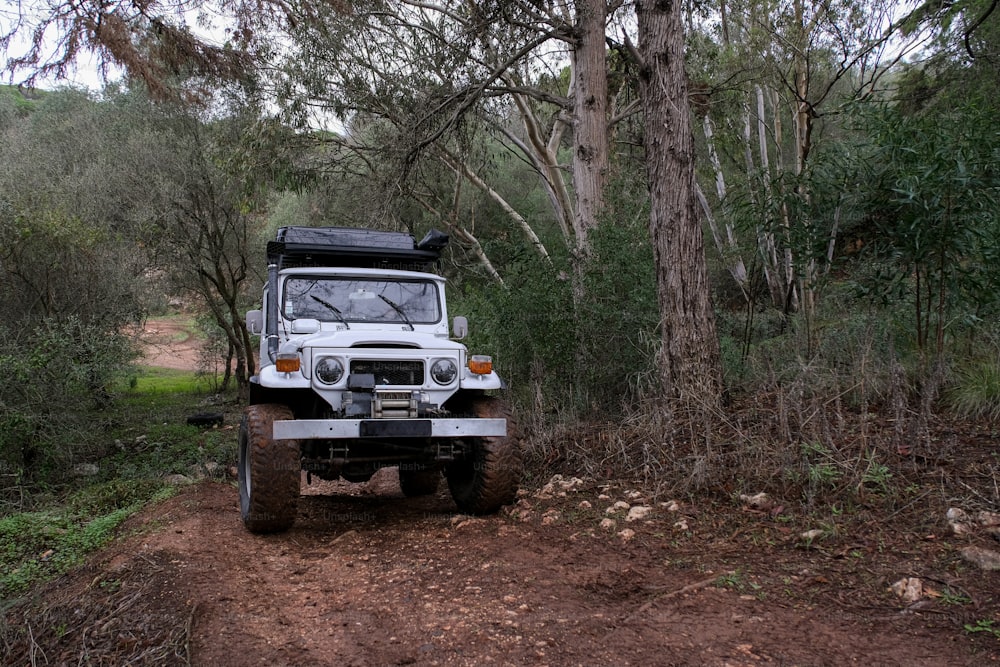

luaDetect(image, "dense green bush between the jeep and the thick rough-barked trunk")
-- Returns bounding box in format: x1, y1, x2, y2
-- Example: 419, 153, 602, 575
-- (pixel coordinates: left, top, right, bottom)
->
450, 196, 659, 417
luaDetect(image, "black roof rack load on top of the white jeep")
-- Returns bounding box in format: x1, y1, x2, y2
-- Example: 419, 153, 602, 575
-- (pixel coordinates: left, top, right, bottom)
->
267, 227, 448, 271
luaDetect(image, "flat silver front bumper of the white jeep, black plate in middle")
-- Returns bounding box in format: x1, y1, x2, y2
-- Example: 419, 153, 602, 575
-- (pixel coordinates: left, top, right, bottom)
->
273, 418, 507, 440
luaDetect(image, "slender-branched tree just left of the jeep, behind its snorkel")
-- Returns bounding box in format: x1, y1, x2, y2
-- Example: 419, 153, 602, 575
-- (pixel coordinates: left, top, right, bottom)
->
129, 93, 269, 395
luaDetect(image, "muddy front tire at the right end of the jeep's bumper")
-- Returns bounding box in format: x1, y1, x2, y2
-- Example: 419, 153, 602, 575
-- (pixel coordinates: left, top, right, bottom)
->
445, 396, 523, 514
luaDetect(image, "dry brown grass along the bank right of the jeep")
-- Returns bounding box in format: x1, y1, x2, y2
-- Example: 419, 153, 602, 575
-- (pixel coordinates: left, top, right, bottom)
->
526, 358, 1000, 507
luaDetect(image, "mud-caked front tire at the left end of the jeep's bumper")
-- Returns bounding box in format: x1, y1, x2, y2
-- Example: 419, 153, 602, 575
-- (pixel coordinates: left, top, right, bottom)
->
239, 404, 301, 533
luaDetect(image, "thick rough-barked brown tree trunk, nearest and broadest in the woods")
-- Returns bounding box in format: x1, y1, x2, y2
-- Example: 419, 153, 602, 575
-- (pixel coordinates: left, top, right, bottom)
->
637, 0, 722, 410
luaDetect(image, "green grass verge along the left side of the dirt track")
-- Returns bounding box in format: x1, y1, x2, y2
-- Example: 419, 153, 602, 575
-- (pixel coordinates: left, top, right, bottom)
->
0, 368, 239, 598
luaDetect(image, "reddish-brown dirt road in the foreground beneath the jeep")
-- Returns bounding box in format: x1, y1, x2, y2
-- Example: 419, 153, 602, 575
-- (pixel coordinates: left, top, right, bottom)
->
9, 470, 1000, 667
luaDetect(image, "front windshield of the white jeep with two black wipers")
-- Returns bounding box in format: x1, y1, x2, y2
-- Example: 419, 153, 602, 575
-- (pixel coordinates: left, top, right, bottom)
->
282, 276, 441, 326
